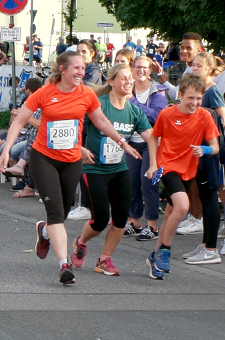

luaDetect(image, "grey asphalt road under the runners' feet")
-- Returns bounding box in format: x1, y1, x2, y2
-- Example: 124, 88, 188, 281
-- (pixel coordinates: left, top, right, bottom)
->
0, 179, 225, 340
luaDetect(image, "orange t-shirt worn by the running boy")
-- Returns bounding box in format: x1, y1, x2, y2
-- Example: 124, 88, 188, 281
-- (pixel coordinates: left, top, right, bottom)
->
152, 105, 220, 181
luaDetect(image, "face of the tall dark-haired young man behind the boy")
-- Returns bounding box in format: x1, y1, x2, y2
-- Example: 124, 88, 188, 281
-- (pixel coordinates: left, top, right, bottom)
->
180, 39, 201, 66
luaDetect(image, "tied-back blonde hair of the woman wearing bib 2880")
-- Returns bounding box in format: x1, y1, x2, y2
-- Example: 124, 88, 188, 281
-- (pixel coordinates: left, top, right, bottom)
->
48, 51, 84, 84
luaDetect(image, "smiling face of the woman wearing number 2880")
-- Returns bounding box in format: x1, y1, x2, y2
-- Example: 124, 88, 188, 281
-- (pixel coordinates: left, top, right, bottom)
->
59, 56, 85, 88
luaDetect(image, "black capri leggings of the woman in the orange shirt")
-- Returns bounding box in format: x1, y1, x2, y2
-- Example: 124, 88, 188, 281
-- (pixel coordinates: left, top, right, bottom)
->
29, 148, 82, 224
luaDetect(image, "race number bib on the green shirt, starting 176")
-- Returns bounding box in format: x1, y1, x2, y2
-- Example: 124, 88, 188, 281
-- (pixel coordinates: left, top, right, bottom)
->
100, 137, 124, 164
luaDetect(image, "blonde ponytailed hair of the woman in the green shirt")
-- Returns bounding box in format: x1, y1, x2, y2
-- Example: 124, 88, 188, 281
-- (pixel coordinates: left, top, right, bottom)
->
88, 64, 131, 97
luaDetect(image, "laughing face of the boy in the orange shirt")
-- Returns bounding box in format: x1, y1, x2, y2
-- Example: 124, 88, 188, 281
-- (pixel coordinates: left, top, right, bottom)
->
178, 87, 203, 114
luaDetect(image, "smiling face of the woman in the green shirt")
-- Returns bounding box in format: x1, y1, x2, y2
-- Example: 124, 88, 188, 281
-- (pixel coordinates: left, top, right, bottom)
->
109, 69, 133, 96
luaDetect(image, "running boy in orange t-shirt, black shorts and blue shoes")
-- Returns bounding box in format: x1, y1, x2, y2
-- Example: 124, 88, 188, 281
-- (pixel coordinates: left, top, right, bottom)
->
146, 74, 219, 279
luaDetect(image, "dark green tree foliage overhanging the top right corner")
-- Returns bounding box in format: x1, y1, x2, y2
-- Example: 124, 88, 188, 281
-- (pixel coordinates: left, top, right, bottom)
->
99, 0, 225, 51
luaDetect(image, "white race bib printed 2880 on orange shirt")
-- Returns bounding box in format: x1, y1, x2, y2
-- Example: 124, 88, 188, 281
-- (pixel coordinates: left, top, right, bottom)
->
47, 119, 78, 150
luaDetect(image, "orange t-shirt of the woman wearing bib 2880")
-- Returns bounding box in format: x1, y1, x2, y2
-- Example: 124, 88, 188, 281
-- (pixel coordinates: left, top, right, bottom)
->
25, 84, 100, 163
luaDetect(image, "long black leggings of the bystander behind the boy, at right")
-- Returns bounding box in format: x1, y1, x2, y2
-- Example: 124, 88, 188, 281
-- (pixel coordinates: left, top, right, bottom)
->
196, 170, 220, 248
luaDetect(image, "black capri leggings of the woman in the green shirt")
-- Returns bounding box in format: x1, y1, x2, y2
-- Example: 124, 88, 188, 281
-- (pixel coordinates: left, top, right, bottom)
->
83, 170, 131, 232
